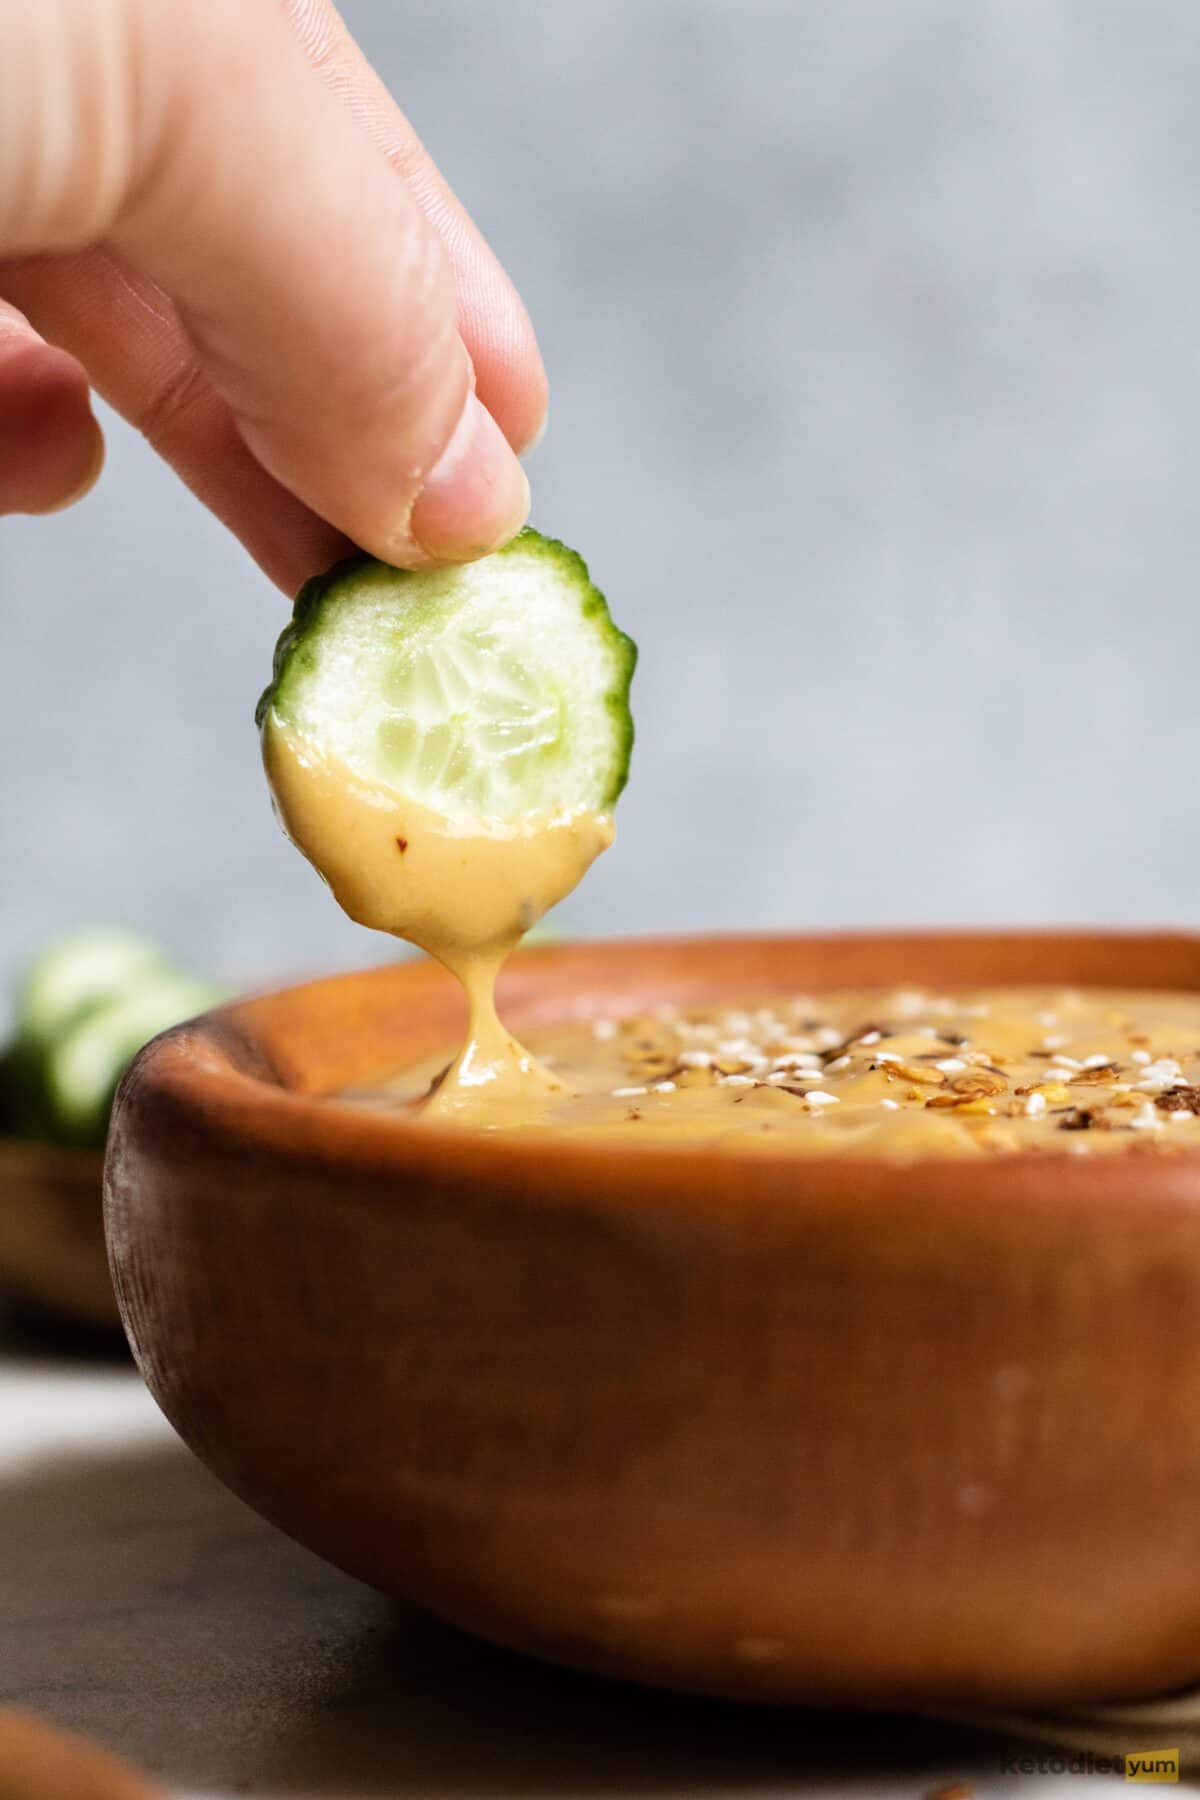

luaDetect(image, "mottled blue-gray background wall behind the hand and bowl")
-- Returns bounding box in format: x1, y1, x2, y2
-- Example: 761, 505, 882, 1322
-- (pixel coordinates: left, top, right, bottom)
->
0, 0, 1200, 1000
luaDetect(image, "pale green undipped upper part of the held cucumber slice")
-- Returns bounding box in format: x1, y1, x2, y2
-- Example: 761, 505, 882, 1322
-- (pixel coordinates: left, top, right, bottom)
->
255, 527, 637, 830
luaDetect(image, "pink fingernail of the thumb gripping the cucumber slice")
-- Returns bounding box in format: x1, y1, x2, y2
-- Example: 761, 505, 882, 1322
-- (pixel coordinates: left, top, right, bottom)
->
408, 392, 529, 562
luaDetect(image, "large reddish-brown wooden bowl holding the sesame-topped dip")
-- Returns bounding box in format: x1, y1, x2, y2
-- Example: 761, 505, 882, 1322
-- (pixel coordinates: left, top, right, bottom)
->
106, 932, 1200, 1706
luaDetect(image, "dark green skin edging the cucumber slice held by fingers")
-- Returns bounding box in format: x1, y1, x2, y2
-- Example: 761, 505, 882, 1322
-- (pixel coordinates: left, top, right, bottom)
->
255, 526, 637, 812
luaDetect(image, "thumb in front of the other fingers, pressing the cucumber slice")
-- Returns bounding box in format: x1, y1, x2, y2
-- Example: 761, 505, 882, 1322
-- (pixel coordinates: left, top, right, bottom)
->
0, 0, 529, 565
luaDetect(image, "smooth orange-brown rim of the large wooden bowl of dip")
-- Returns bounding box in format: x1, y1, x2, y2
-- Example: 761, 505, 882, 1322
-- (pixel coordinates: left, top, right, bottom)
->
110, 927, 1200, 1211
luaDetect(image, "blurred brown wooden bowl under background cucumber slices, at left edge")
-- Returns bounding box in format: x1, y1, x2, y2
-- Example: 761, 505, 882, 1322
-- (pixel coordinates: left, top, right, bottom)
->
0, 1138, 121, 1343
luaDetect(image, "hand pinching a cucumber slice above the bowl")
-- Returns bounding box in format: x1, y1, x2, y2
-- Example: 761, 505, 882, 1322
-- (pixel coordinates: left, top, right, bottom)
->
0, 0, 545, 590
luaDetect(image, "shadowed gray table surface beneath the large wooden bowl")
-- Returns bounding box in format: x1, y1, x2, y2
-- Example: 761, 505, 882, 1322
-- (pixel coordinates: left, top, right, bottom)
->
0, 1316, 1112, 1800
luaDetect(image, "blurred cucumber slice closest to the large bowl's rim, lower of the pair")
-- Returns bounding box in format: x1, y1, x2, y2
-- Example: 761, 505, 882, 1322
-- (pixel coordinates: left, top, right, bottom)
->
43, 970, 225, 1145
